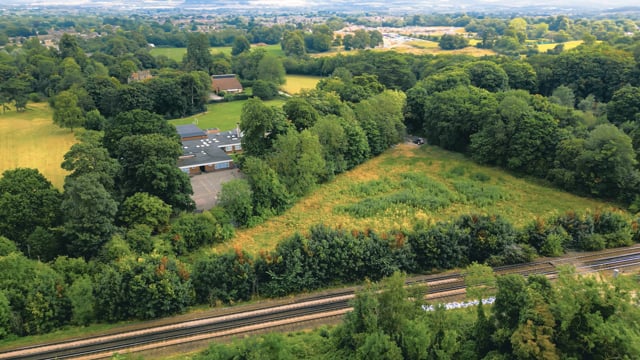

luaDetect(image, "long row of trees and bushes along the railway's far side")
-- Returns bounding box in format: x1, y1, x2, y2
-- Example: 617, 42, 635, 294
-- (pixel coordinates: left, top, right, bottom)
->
0, 208, 640, 336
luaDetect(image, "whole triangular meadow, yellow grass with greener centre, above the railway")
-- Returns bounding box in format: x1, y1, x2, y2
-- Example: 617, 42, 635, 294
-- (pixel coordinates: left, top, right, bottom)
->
214, 144, 613, 254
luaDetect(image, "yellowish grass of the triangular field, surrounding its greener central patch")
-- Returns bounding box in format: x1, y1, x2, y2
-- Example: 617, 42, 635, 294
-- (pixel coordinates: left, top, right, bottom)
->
213, 143, 612, 254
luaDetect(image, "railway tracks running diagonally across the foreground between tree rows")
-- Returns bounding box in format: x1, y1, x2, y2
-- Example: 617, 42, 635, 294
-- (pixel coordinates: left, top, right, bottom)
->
5, 245, 640, 360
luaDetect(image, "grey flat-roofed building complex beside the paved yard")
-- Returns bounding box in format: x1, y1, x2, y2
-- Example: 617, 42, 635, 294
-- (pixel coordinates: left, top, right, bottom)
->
176, 124, 242, 175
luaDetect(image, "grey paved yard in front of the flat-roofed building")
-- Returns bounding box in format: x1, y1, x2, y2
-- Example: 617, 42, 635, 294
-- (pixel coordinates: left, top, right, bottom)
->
191, 169, 242, 210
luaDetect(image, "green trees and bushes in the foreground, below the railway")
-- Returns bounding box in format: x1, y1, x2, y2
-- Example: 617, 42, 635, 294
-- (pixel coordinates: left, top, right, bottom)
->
195, 265, 640, 360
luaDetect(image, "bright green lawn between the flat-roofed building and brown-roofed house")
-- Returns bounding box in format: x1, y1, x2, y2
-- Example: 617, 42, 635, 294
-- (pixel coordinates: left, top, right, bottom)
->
169, 99, 284, 131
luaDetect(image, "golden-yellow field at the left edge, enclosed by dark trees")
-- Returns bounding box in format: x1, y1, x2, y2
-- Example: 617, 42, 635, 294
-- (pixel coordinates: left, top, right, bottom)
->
0, 103, 76, 188
